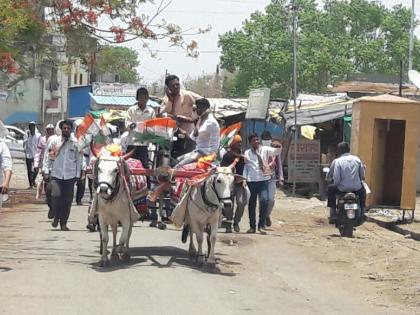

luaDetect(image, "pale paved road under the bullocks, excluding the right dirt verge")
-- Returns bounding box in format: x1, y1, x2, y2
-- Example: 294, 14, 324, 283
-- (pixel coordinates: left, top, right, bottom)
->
0, 201, 410, 315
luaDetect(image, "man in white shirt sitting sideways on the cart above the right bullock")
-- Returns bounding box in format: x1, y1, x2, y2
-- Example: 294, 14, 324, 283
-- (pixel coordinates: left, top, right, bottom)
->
177, 98, 220, 166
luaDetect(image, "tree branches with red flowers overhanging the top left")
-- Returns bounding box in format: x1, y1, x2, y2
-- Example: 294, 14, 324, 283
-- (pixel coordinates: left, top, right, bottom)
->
0, 0, 207, 86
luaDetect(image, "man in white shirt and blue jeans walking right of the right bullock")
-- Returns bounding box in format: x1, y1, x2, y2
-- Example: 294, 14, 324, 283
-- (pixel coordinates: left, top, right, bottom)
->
244, 134, 281, 234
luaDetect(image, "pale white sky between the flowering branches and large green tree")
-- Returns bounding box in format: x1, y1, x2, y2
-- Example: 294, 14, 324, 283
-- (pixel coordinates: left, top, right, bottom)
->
115, 0, 420, 83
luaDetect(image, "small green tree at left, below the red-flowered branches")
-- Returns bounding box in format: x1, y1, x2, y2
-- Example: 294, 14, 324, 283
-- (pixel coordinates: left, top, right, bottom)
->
96, 46, 140, 83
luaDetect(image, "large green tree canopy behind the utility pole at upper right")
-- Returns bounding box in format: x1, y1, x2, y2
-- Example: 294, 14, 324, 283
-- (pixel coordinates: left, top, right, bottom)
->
219, 0, 420, 97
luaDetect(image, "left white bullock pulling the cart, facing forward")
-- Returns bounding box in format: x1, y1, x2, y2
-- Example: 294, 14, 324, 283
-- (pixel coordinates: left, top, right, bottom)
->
89, 156, 139, 266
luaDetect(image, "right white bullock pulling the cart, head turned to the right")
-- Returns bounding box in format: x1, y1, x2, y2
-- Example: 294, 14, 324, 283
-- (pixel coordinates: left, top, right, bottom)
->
183, 167, 235, 266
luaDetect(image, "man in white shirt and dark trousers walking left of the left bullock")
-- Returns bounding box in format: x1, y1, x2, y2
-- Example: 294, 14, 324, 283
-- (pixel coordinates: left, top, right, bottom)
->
42, 121, 82, 231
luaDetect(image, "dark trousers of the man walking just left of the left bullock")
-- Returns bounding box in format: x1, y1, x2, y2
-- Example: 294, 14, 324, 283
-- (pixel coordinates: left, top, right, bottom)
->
50, 177, 76, 225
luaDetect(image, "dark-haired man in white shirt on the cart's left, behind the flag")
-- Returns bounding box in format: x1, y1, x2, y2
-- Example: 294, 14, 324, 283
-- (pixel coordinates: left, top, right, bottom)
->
125, 88, 156, 168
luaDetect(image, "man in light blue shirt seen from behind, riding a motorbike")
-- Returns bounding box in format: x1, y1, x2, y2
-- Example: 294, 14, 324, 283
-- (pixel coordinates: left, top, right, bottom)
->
327, 142, 366, 224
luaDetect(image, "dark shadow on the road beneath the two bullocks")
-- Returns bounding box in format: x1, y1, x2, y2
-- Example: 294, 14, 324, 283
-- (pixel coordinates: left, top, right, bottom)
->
91, 246, 237, 277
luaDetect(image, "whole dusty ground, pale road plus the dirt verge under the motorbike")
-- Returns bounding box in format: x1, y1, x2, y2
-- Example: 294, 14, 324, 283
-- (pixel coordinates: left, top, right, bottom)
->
0, 194, 420, 315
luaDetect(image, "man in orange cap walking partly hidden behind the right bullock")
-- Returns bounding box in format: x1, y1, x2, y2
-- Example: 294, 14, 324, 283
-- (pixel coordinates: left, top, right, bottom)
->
220, 135, 250, 233
